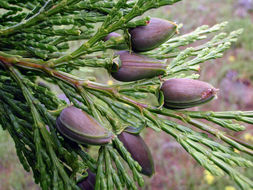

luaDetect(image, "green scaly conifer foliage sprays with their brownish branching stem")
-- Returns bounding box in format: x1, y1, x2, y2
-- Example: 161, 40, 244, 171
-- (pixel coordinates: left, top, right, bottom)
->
0, 0, 253, 189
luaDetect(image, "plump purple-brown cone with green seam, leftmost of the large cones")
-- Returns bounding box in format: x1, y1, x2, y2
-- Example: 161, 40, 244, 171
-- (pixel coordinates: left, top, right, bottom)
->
56, 106, 112, 145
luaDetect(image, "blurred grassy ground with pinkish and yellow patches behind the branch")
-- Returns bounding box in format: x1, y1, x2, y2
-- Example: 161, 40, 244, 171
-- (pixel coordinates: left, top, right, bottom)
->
0, 0, 253, 190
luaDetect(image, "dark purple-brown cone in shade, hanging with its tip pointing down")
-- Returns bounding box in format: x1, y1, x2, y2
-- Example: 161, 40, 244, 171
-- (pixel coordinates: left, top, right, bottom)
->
118, 132, 155, 176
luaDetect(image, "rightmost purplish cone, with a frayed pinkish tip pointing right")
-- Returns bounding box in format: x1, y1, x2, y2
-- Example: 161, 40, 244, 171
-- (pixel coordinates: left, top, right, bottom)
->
161, 78, 217, 109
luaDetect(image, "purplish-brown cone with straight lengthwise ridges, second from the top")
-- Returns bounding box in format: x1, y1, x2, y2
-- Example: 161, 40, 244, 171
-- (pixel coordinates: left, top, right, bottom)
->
111, 51, 167, 82
